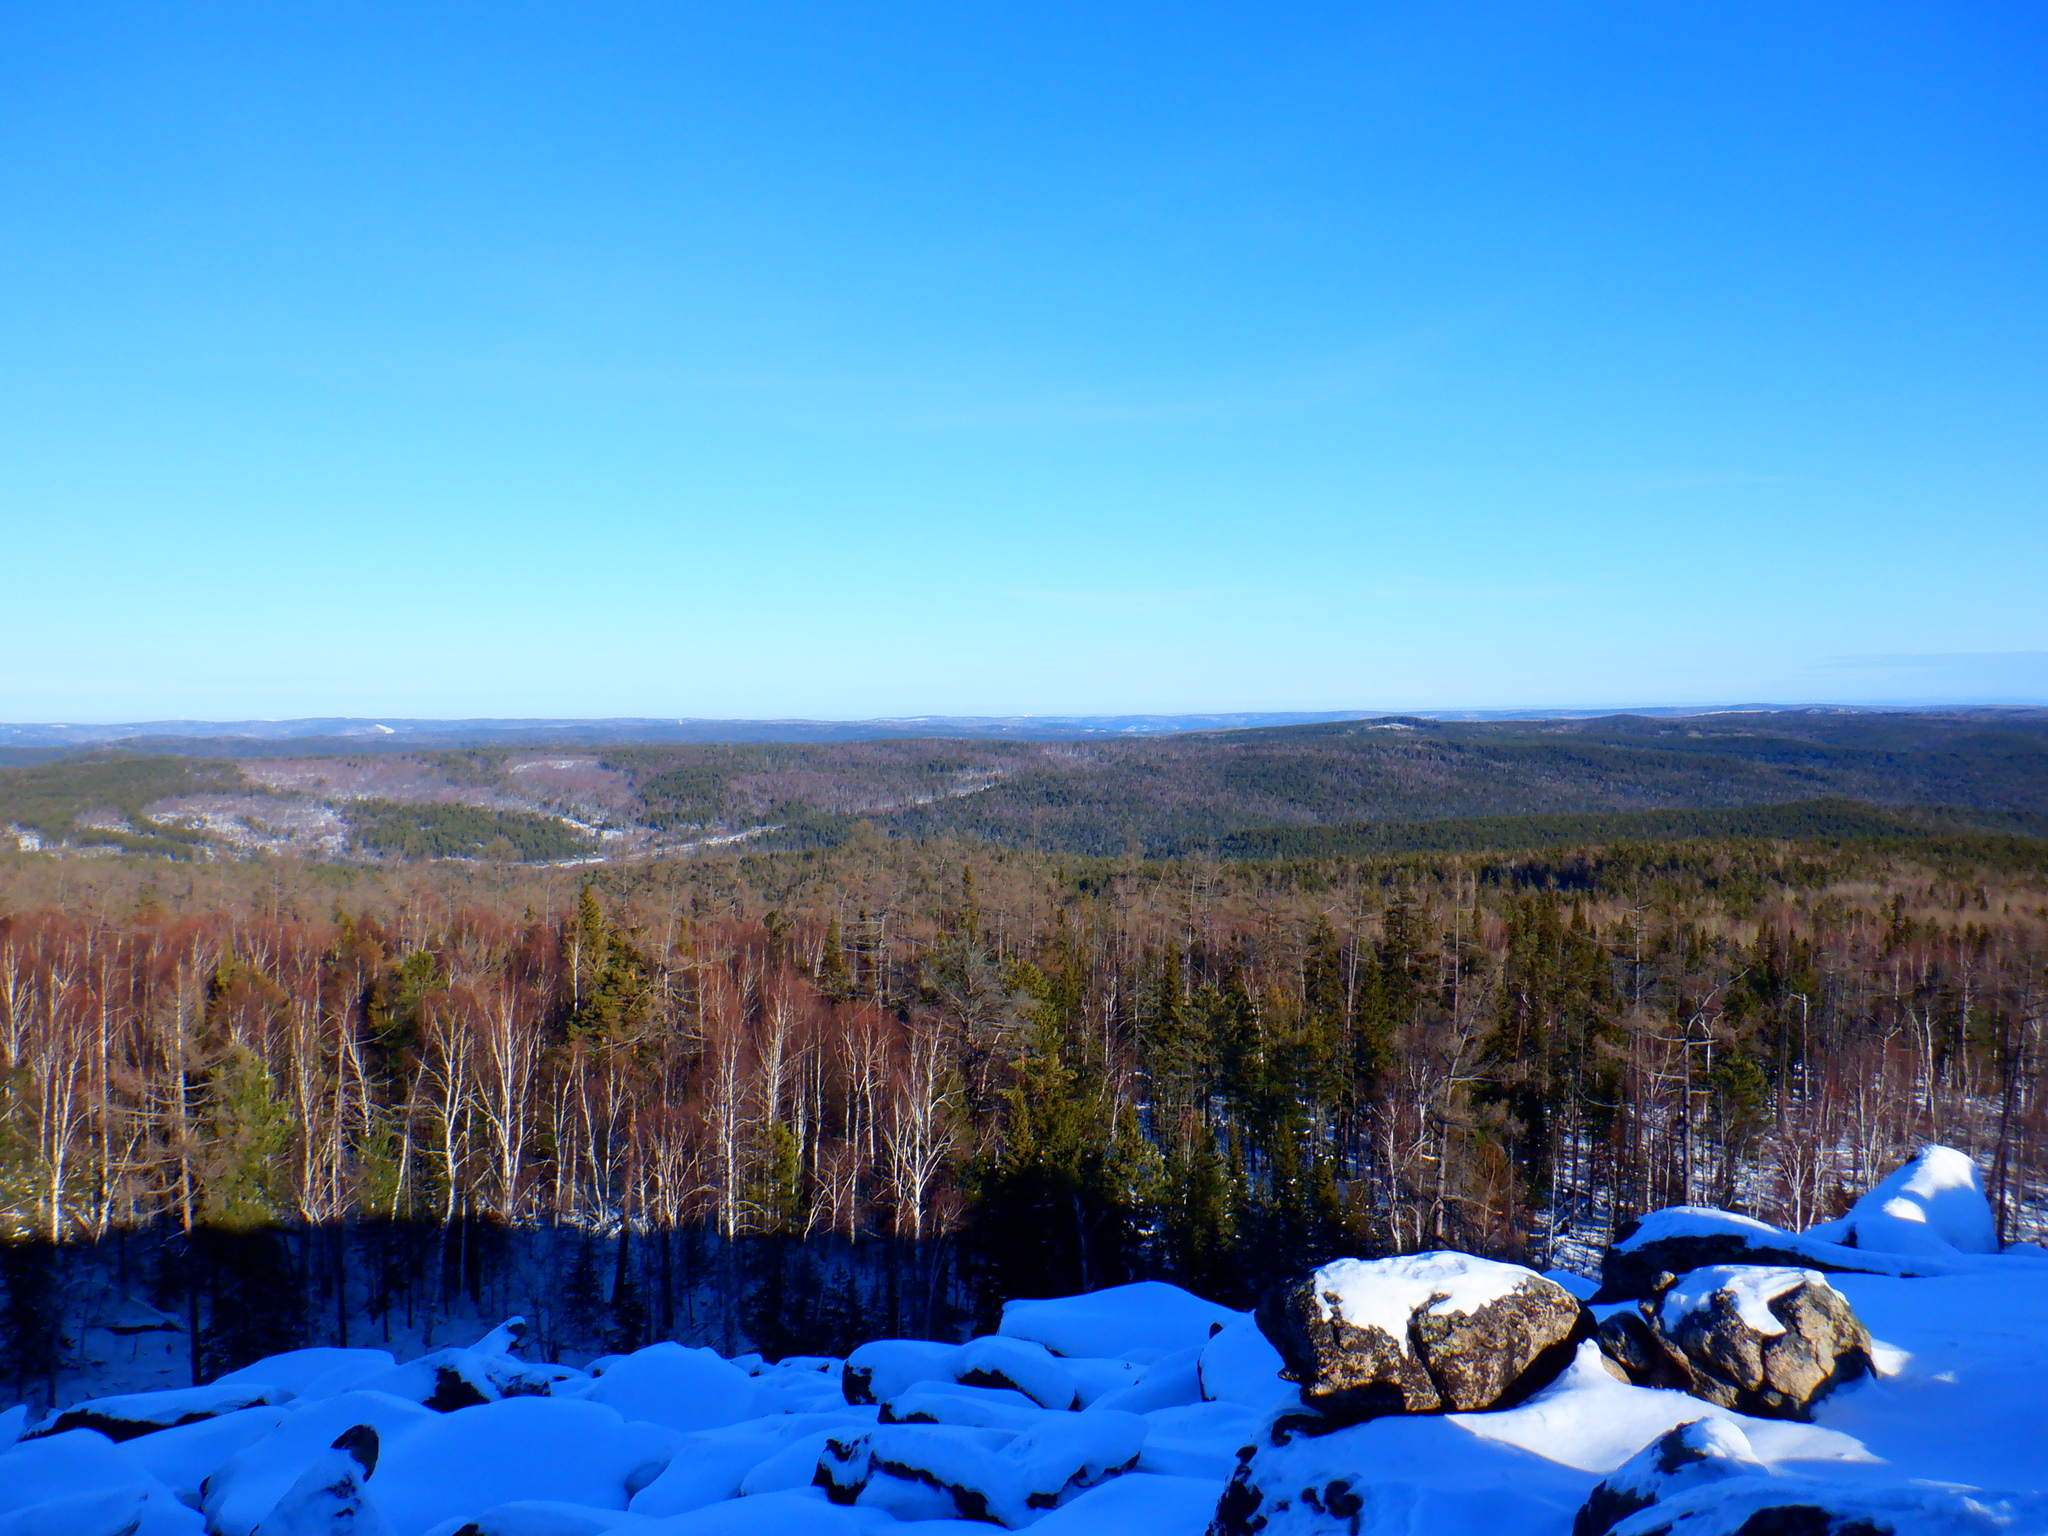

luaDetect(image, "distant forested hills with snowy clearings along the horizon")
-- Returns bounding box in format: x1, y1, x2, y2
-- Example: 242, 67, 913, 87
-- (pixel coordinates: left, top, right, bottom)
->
0, 709, 2048, 862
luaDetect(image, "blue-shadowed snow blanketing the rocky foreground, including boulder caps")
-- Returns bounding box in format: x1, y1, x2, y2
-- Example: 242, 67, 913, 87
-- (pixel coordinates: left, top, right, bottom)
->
0, 1149, 2048, 1536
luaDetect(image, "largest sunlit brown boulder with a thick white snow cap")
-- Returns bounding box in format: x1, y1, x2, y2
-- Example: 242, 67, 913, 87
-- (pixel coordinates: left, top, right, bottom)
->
1257, 1253, 1591, 1427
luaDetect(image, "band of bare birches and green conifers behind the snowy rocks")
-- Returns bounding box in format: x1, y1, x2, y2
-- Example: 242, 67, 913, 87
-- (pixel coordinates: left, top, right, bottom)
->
0, 843, 2048, 1368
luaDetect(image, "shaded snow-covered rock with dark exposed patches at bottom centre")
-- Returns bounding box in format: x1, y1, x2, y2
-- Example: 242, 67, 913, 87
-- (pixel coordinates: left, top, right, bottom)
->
817, 1409, 1145, 1530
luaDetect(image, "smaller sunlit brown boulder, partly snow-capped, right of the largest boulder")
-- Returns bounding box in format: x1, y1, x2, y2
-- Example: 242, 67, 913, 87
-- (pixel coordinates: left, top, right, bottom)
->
1642, 1264, 1872, 1419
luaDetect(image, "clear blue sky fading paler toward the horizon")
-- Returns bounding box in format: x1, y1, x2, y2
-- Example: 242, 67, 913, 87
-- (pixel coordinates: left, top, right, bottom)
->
0, 0, 2048, 721
